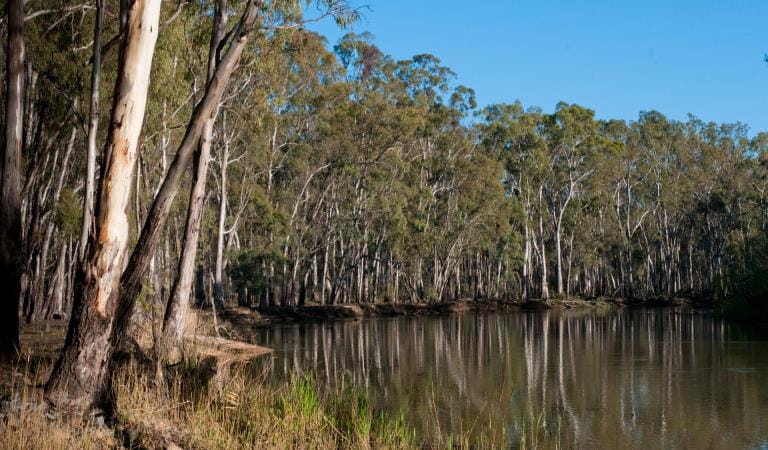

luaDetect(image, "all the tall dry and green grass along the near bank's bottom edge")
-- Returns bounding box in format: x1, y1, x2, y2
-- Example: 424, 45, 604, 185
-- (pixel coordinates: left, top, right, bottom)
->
0, 356, 416, 449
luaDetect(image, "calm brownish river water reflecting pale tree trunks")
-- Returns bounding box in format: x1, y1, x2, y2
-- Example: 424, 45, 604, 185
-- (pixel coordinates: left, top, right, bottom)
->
250, 308, 768, 449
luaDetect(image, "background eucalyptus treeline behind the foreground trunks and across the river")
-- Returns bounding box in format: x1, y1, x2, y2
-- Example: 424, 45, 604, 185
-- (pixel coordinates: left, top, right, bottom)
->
9, 8, 768, 320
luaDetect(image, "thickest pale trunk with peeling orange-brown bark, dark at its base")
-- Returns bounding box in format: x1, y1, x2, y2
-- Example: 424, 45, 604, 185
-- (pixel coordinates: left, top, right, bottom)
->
46, 0, 161, 414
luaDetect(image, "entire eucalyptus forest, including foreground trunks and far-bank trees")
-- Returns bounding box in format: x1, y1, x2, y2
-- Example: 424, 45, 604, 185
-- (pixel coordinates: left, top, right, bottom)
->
0, 0, 768, 448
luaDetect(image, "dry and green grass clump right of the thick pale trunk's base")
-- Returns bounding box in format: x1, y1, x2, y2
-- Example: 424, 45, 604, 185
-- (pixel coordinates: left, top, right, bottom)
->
115, 356, 414, 449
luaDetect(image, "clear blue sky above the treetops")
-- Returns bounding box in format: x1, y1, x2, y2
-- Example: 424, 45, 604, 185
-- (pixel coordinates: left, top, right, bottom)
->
309, 0, 768, 134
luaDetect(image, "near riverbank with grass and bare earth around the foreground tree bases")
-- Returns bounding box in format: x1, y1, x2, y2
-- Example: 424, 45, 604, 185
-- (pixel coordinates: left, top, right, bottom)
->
0, 313, 416, 450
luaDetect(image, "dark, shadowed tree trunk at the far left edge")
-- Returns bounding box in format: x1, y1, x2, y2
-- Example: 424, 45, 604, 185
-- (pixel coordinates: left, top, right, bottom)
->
0, 0, 24, 359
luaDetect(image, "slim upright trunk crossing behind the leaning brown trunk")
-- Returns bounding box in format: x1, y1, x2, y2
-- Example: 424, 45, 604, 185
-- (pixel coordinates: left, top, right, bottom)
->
163, 0, 227, 359
